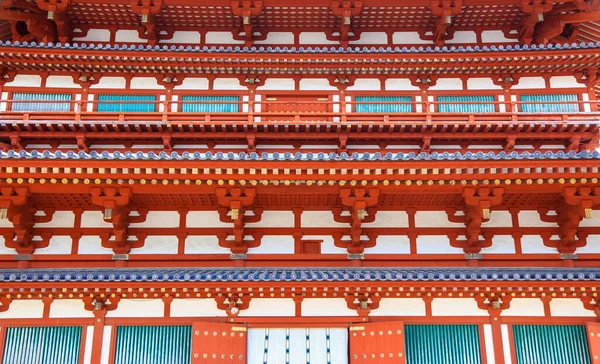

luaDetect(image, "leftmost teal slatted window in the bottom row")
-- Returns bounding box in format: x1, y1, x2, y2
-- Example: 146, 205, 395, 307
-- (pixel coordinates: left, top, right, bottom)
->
2, 326, 82, 364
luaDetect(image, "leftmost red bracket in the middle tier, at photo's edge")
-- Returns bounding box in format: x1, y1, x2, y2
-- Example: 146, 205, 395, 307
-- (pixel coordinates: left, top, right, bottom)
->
0, 187, 55, 255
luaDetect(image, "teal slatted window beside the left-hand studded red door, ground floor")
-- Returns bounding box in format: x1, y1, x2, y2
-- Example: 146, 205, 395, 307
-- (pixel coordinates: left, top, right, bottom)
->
115, 326, 192, 364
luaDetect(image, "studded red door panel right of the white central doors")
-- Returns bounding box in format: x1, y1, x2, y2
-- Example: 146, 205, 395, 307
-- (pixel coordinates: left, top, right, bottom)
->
350, 321, 406, 364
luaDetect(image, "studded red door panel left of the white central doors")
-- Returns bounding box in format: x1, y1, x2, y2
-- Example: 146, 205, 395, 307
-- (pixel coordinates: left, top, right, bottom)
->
192, 322, 248, 364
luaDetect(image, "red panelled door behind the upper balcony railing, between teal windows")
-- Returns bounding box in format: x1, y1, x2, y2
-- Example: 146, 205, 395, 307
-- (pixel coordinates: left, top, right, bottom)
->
265, 95, 332, 121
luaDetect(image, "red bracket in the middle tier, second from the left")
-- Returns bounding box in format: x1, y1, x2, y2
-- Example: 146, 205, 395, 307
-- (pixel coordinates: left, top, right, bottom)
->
90, 187, 148, 260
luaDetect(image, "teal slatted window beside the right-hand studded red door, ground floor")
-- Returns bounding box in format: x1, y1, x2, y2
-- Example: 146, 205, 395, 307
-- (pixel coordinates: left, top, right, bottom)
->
404, 325, 481, 364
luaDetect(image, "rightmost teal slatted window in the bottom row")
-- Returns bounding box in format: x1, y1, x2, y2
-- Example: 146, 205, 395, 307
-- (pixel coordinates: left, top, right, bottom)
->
512, 325, 590, 364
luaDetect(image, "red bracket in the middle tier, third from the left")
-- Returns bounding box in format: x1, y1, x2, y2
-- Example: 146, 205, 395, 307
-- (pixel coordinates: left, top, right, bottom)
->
215, 188, 263, 259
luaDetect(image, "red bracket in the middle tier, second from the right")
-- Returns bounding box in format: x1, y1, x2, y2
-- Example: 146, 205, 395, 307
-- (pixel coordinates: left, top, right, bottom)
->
446, 187, 504, 260
